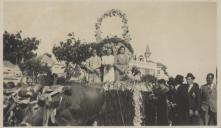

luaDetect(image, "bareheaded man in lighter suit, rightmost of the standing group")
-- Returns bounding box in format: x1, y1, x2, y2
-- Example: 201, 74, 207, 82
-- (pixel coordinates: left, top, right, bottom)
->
201, 73, 217, 125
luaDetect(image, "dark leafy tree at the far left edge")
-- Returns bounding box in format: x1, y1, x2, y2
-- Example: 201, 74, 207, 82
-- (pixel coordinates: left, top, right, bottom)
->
3, 31, 40, 64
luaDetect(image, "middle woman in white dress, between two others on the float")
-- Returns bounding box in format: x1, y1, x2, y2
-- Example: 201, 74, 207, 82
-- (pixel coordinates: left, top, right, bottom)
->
101, 48, 114, 82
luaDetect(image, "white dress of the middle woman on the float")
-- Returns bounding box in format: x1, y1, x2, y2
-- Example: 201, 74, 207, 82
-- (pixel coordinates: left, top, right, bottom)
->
102, 55, 115, 82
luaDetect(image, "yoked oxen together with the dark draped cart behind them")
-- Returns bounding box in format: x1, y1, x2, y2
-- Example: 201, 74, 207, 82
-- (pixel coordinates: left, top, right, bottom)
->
4, 81, 155, 126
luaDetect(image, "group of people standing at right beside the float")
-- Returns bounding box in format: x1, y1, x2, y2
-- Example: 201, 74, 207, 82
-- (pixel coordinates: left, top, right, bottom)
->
154, 73, 217, 125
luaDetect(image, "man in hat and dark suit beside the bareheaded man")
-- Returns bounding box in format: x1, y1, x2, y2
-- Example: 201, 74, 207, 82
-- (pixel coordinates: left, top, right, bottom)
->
178, 73, 200, 125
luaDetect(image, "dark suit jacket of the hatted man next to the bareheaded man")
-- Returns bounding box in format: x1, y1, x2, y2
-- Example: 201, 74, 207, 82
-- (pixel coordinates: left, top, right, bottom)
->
178, 83, 200, 111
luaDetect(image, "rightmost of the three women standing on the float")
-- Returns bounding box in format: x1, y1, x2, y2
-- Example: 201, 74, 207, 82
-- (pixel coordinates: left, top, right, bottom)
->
114, 46, 130, 81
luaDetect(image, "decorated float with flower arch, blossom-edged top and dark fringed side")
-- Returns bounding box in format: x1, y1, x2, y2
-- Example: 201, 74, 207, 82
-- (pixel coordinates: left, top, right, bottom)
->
92, 9, 161, 126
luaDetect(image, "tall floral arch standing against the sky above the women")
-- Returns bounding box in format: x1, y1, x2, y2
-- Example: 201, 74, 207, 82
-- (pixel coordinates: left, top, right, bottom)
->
95, 9, 131, 42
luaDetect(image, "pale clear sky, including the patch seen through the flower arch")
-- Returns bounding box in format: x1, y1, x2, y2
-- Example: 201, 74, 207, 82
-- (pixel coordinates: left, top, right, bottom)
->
3, 1, 217, 84
